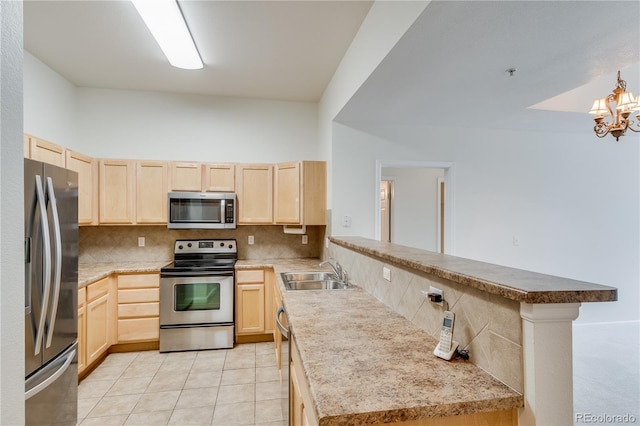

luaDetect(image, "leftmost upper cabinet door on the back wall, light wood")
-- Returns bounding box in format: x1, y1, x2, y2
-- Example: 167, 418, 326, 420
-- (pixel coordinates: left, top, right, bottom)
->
100, 160, 135, 224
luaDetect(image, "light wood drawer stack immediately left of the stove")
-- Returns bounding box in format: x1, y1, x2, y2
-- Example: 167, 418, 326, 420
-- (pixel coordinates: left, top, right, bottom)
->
118, 274, 160, 343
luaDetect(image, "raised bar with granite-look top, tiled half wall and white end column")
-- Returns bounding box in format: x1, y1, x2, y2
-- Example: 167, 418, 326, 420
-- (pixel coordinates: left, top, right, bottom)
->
324, 237, 617, 425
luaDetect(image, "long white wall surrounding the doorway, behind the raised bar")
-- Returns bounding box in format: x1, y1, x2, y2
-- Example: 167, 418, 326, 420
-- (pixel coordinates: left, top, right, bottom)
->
333, 123, 640, 322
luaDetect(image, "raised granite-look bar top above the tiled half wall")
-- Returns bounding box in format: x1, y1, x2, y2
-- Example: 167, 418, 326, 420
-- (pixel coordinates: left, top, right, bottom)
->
330, 237, 618, 304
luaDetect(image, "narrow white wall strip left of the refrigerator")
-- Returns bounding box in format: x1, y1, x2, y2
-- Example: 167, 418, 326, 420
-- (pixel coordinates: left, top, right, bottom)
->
0, 1, 24, 425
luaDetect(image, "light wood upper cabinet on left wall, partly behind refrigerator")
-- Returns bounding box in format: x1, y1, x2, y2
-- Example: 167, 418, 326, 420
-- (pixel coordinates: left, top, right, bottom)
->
66, 149, 98, 225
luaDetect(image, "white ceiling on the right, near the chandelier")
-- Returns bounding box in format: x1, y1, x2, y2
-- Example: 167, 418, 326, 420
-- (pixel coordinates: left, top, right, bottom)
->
338, 1, 640, 132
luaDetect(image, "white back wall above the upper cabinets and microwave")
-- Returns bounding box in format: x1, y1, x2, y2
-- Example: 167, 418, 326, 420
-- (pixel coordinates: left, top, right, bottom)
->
77, 88, 321, 163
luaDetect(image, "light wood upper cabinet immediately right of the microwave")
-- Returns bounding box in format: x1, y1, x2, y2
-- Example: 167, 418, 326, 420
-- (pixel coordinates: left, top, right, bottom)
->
236, 164, 273, 224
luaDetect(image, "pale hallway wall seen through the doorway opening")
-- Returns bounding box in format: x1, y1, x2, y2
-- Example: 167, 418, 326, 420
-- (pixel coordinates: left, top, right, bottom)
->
382, 167, 444, 251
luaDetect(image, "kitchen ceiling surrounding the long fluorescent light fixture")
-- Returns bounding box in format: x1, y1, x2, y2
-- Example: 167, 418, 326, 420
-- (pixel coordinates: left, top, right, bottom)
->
24, 0, 372, 101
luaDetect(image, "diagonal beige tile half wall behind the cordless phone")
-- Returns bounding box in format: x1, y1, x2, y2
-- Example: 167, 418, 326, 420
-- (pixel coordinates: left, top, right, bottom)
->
328, 244, 524, 393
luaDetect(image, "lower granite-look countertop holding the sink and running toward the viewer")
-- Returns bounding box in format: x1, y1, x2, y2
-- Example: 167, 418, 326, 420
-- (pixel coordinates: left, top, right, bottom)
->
236, 259, 524, 425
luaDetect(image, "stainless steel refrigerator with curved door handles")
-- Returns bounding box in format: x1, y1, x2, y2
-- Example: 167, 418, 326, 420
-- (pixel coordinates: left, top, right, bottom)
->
24, 159, 78, 425
